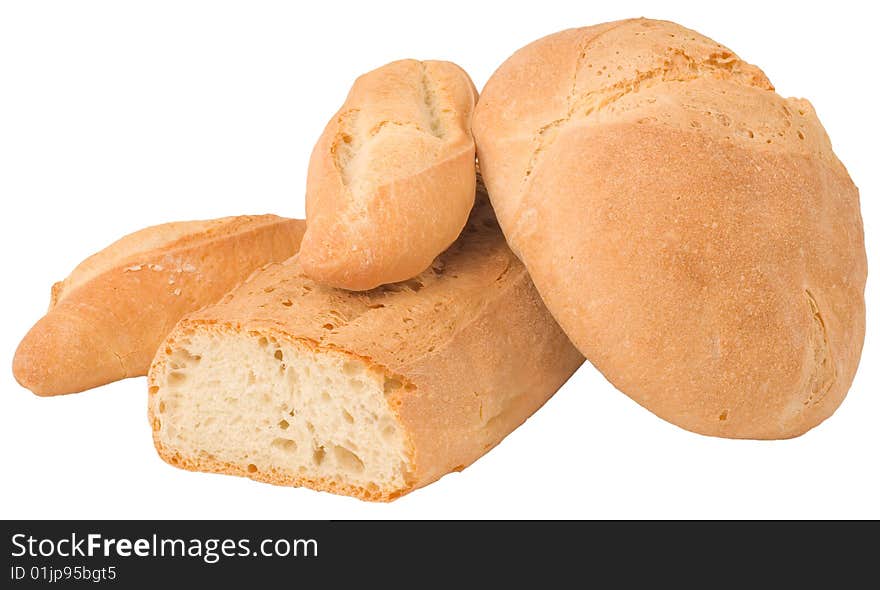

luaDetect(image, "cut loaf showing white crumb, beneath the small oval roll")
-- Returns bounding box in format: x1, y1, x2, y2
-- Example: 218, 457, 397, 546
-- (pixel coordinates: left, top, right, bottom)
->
148, 187, 583, 501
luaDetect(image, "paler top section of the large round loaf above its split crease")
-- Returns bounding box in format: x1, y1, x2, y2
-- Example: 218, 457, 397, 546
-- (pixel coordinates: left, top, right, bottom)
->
473, 19, 773, 240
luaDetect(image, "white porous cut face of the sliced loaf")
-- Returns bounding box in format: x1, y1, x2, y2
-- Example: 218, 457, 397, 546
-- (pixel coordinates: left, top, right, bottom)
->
149, 325, 412, 501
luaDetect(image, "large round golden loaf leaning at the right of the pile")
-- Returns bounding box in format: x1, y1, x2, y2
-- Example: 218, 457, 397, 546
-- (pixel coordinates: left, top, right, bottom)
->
474, 19, 866, 439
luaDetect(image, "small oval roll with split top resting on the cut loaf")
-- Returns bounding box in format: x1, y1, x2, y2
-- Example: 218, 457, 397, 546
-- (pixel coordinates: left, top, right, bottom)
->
300, 59, 477, 290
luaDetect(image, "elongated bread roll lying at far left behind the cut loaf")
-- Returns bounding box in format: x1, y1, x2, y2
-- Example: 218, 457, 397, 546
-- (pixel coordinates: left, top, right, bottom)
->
13, 215, 305, 395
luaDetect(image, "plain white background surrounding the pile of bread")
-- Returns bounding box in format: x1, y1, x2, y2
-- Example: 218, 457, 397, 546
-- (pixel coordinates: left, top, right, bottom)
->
0, 0, 880, 519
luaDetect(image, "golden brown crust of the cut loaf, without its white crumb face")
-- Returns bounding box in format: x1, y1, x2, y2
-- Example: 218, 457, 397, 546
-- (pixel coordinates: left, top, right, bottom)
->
149, 188, 583, 500
